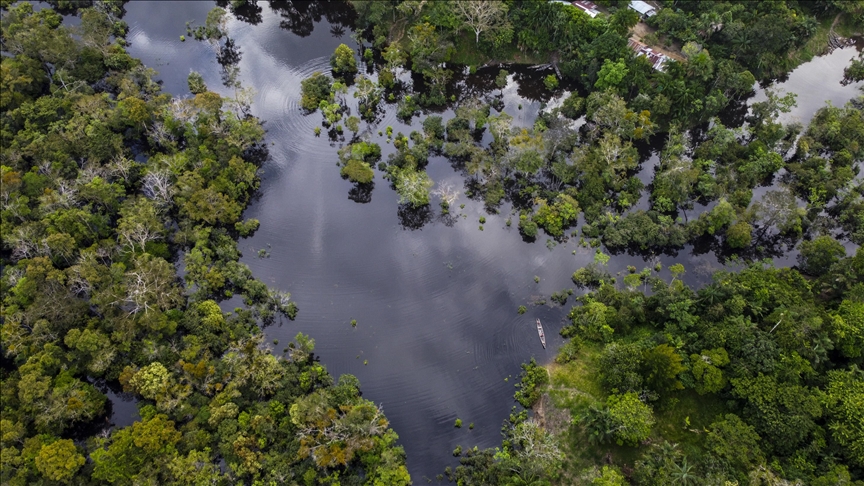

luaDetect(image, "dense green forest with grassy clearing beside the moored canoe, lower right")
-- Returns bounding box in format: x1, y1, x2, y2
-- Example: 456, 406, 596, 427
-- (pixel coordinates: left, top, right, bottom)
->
450, 249, 864, 485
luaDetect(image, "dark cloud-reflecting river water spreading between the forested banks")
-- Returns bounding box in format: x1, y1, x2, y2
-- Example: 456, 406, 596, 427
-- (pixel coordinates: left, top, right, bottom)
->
125, 1, 857, 483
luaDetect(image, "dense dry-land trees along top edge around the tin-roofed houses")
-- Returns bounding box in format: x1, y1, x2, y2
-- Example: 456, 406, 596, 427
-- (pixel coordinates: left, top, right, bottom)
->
351, 0, 836, 124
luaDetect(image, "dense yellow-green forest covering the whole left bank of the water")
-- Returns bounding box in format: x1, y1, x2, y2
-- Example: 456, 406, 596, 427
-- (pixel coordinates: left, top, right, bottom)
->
0, 3, 410, 485
